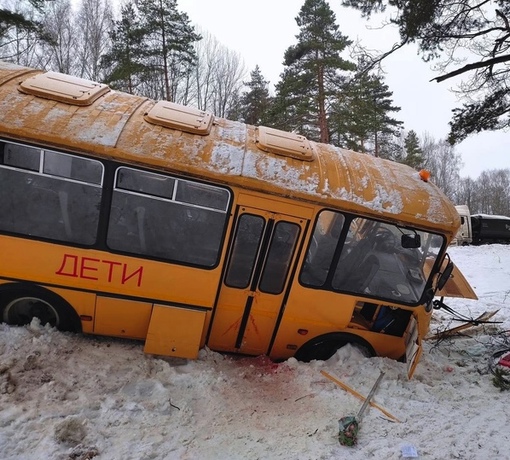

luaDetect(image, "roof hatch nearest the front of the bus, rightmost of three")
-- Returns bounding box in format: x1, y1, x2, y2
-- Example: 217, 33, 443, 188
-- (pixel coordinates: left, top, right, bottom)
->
257, 126, 313, 161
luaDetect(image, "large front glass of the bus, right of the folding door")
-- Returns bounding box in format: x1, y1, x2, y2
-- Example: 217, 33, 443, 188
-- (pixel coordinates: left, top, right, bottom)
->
300, 211, 444, 304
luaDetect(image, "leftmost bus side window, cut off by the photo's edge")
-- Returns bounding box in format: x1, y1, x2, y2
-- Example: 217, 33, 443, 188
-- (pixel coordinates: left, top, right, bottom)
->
0, 144, 103, 245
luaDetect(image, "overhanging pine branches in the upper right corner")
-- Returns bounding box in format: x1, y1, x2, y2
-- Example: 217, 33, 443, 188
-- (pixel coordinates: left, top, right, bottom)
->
341, 0, 510, 143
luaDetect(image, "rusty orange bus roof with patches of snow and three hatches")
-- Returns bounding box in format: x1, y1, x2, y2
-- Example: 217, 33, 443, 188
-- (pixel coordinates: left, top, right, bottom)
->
0, 61, 460, 236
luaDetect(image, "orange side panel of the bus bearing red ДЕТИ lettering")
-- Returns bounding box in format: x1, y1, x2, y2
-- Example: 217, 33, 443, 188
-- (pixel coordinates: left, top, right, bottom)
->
0, 236, 221, 308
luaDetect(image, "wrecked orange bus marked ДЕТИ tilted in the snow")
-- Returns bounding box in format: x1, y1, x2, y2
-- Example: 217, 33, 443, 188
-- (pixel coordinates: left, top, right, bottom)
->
0, 62, 476, 377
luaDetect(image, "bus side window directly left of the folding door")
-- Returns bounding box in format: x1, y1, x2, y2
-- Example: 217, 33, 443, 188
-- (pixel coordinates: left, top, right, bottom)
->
107, 167, 230, 267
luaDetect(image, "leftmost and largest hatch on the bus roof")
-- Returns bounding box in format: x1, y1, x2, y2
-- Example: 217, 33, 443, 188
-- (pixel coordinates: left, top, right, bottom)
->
18, 72, 110, 105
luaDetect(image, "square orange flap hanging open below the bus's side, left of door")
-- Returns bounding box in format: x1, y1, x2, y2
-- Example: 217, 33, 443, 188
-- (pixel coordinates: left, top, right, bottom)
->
143, 305, 206, 359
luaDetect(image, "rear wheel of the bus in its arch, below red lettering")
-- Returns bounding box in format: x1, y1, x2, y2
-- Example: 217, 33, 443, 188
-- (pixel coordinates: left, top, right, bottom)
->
0, 284, 81, 332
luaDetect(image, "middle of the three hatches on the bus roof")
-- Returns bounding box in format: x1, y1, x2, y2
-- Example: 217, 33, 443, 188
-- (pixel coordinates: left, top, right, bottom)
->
144, 101, 214, 136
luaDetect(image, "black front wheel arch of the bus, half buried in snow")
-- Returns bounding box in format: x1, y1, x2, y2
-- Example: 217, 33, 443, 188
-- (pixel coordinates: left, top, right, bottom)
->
294, 332, 376, 363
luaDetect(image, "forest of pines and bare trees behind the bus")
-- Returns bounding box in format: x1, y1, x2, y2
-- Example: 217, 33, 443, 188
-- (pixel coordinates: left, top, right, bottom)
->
0, 0, 510, 216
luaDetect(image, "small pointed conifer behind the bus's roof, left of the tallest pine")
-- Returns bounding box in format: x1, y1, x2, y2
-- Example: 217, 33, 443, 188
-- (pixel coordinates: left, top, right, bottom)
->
239, 65, 271, 125
